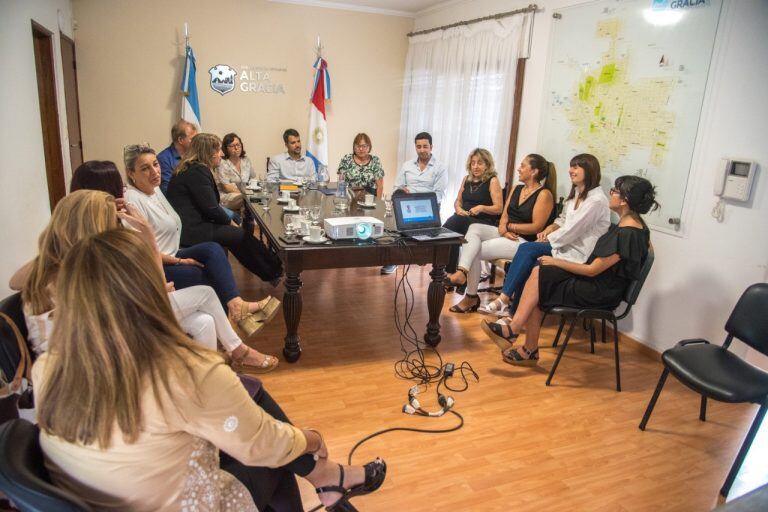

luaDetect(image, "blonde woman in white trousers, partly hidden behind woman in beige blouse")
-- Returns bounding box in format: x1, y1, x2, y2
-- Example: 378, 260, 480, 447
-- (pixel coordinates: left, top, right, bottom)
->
10, 190, 278, 373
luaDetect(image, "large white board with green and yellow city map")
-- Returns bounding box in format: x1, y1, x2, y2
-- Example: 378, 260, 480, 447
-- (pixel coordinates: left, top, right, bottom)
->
539, 0, 722, 229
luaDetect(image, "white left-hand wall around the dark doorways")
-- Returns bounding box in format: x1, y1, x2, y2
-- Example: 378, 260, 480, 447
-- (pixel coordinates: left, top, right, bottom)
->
0, 0, 72, 297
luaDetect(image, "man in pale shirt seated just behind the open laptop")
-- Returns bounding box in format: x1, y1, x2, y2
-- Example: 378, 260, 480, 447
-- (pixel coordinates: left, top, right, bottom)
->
381, 132, 448, 274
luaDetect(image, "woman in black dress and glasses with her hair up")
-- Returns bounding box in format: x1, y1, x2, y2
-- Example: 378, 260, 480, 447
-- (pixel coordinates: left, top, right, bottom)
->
482, 176, 658, 365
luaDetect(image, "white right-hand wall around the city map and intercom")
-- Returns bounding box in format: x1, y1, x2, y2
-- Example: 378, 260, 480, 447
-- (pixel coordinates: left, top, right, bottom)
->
415, 0, 768, 367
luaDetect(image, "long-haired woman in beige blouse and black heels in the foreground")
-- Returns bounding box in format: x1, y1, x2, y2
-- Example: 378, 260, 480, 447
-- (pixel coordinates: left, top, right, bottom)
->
33, 229, 386, 511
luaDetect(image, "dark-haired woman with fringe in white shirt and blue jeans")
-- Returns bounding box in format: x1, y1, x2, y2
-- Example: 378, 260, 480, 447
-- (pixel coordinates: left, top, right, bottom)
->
486, 153, 611, 316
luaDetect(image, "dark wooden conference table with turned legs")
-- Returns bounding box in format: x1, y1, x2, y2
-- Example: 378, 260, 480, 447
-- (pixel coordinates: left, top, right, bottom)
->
245, 186, 462, 362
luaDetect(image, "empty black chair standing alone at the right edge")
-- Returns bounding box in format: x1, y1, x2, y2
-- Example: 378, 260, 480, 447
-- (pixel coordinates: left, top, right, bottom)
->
640, 283, 768, 498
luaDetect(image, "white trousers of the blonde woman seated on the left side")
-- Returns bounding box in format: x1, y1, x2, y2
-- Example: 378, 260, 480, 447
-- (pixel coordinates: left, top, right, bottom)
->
168, 285, 243, 353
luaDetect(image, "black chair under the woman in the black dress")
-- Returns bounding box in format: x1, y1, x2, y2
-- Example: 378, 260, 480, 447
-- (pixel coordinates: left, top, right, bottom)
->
542, 246, 655, 391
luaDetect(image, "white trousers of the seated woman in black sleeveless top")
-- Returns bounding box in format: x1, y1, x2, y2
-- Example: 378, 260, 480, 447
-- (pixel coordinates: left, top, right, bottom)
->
459, 223, 525, 295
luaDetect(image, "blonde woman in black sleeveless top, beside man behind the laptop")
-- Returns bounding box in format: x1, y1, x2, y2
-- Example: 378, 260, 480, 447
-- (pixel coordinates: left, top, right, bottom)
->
443, 148, 504, 280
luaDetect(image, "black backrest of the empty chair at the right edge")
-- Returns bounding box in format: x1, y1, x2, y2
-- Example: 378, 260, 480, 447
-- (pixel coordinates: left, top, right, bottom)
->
725, 283, 768, 355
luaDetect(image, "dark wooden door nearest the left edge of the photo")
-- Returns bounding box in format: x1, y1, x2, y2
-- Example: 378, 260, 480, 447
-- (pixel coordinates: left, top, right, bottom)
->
32, 21, 66, 210
